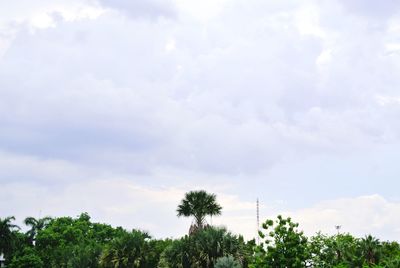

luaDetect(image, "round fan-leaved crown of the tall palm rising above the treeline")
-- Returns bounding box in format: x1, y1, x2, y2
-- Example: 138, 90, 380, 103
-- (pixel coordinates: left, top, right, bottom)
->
176, 190, 222, 230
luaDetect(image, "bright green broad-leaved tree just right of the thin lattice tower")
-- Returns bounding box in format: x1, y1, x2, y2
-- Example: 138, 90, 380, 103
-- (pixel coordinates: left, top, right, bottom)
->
251, 216, 310, 268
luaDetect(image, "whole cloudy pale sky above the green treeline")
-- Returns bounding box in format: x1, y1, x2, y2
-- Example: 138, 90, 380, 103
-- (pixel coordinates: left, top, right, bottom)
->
0, 0, 400, 240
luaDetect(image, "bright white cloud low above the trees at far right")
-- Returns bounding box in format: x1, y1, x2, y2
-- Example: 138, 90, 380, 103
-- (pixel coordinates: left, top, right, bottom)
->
290, 194, 400, 240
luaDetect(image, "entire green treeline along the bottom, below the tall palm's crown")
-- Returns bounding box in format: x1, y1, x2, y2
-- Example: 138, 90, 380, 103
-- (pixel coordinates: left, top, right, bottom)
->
0, 213, 400, 268
